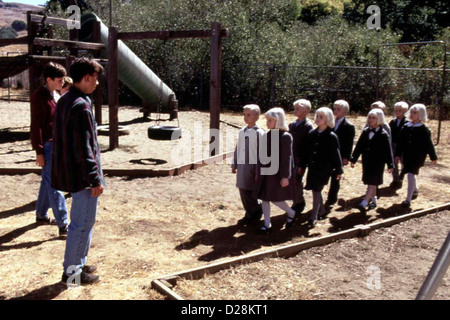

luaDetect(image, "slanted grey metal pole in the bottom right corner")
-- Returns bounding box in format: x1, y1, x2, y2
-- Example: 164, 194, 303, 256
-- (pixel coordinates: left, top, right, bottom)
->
416, 232, 450, 300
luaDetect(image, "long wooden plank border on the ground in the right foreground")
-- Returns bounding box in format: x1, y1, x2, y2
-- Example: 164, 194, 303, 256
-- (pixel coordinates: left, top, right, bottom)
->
152, 202, 450, 300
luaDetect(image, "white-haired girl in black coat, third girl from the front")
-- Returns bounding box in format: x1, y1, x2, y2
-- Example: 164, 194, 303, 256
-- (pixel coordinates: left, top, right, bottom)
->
350, 109, 394, 214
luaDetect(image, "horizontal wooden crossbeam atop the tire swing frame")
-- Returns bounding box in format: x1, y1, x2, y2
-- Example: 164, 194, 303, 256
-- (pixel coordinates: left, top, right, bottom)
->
118, 29, 229, 40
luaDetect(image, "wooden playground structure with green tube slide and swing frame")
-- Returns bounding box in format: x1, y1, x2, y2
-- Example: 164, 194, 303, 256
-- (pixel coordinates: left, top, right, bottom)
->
0, 7, 228, 152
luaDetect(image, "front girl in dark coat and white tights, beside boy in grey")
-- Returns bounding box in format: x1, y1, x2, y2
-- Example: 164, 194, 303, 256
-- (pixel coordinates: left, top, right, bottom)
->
255, 108, 299, 234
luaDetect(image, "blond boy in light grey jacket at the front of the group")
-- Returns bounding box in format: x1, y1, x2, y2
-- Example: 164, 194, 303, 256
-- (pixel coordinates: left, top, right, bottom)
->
231, 104, 264, 225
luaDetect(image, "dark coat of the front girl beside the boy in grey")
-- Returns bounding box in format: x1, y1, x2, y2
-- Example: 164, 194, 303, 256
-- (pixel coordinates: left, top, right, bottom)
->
254, 130, 300, 202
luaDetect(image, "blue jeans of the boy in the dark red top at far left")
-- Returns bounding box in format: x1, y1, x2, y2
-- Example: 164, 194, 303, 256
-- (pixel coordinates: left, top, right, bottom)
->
36, 142, 67, 228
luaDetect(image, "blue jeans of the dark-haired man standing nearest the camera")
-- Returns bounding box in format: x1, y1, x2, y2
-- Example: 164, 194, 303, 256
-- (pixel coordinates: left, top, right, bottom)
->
63, 189, 98, 276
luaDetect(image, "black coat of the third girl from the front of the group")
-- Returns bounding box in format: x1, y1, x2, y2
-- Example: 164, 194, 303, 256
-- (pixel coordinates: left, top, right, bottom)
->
350, 127, 394, 186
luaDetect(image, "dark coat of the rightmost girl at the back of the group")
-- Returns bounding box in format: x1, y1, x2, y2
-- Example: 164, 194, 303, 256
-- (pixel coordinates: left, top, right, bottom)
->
395, 123, 437, 174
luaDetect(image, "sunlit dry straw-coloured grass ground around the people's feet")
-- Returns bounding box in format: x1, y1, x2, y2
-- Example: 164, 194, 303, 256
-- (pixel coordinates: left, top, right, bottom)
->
0, 102, 450, 300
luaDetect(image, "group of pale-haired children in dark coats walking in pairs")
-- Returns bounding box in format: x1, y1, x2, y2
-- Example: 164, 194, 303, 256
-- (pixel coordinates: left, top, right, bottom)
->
233, 99, 437, 233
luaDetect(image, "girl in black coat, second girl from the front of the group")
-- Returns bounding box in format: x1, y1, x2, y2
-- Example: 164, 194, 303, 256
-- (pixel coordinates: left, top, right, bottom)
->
301, 107, 344, 227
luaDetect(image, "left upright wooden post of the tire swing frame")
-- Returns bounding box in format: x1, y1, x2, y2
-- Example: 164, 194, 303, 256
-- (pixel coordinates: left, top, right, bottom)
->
108, 27, 119, 150
